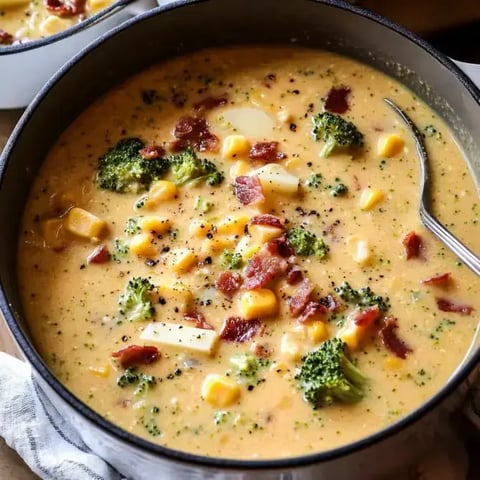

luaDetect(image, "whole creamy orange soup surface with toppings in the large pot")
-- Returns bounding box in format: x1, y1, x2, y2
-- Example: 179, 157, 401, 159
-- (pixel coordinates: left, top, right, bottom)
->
18, 47, 480, 458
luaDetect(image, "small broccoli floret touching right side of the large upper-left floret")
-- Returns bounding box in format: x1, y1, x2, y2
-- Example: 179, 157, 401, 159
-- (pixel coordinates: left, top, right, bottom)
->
170, 148, 224, 186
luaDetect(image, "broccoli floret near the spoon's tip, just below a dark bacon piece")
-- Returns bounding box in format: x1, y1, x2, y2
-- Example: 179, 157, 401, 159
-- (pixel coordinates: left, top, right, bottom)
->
312, 112, 363, 158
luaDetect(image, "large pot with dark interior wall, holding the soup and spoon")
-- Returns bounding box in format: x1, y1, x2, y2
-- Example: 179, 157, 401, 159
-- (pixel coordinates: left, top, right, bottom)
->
0, 0, 480, 480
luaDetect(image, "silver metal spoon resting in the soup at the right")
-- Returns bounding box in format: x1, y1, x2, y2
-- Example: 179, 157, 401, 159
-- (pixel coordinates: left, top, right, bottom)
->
383, 98, 480, 275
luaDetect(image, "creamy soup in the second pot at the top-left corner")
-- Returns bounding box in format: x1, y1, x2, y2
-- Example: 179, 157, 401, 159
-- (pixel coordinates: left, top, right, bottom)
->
0, 0, 113, 43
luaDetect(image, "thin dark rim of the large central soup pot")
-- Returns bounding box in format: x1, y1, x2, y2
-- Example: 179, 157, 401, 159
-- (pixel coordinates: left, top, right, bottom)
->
0, 0, 480, 471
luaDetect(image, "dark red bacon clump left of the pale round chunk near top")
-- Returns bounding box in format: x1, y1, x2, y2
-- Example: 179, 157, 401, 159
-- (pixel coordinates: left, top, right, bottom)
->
172, 116, 218, 152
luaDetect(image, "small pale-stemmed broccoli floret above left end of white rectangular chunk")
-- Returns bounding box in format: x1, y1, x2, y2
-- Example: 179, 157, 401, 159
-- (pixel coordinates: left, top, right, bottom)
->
118, 277, 155, 322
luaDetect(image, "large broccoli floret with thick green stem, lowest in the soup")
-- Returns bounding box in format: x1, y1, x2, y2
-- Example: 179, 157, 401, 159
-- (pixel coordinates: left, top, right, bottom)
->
295, 338, 368, 408
